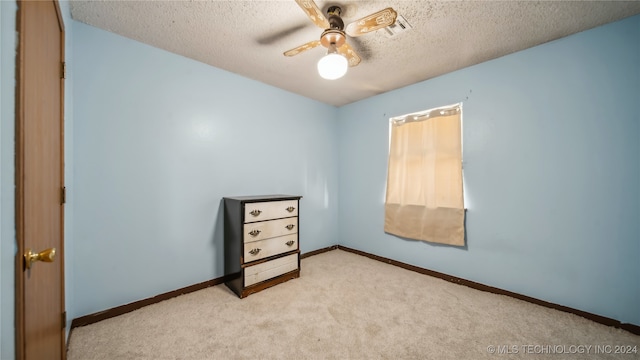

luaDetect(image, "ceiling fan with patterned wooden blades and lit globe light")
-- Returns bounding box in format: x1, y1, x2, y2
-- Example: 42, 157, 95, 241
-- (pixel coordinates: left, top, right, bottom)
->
284, 0, 398, 80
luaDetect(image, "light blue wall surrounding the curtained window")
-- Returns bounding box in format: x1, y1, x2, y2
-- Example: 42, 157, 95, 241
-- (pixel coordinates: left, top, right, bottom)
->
338, 16, 640, 325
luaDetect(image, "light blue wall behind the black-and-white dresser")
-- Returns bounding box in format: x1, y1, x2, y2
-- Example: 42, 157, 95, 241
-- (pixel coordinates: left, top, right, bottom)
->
68, 22, 338, 317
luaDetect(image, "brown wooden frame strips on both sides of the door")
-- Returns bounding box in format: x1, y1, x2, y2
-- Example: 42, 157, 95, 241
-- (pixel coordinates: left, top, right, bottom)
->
15, 0, 66, 360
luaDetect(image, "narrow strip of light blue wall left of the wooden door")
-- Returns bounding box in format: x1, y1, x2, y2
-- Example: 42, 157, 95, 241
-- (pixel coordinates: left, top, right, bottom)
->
0, 1, 17, 359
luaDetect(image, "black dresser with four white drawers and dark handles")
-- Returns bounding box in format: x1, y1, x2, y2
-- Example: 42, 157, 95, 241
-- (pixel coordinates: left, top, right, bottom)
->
224, 195, 301, 298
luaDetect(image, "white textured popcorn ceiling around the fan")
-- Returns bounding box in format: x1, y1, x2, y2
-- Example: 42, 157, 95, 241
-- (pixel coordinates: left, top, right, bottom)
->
71, 0, 640, 106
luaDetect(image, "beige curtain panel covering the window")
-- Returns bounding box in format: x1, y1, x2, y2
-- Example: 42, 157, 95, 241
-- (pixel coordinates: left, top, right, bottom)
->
384, 104, 465, 246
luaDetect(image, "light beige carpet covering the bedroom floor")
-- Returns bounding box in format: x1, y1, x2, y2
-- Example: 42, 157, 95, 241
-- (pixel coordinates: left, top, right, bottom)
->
68, 250, 640, 360
